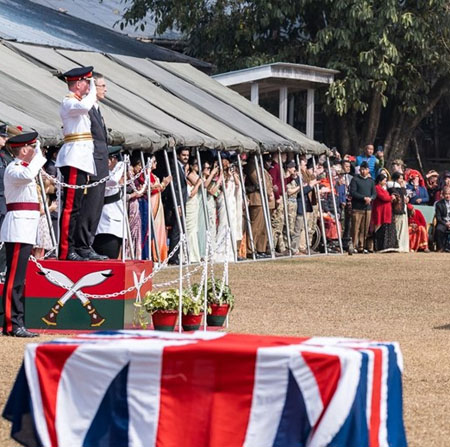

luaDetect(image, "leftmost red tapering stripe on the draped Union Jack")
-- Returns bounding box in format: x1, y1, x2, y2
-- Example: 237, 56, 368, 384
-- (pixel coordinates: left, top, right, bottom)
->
35, 344, 78, 447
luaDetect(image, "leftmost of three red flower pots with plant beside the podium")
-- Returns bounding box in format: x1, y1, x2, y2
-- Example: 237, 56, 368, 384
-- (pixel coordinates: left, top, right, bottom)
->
142, 289, 179, 331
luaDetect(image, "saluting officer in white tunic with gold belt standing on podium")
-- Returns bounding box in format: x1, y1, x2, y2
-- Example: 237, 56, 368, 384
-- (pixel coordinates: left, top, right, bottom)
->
55, 67, 97, 261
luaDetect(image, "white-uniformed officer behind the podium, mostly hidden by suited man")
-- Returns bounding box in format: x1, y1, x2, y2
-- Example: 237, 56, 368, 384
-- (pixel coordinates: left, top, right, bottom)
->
94, 146, 126, 259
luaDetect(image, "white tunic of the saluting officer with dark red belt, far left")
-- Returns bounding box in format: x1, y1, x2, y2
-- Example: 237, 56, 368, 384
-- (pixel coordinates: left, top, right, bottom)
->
0, 150, 47, 245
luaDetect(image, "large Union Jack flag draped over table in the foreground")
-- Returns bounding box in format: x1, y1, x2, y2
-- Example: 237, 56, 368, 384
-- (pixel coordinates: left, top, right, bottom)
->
3, 331, 407, 447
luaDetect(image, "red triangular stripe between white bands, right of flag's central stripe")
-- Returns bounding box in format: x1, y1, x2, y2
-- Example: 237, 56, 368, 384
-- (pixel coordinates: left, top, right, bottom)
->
301, 352, 341, 425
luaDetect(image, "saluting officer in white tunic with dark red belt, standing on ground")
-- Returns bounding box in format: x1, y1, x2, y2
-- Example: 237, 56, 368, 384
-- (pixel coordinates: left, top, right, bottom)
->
0, 132, 47, 337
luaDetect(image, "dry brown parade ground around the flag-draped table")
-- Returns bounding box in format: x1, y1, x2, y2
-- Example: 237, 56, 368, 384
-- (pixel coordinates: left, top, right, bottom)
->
0, 253, 450, 447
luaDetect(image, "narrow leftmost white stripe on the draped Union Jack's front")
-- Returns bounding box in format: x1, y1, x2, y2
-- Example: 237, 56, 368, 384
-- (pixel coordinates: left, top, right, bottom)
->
24, 343, 51, 447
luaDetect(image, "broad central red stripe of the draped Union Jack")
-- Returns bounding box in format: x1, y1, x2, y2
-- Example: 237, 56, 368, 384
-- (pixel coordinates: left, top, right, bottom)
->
156, 334, 306, 447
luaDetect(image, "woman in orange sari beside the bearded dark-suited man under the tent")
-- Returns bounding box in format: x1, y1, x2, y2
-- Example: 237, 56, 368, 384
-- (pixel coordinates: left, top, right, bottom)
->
150, 157, 172, 262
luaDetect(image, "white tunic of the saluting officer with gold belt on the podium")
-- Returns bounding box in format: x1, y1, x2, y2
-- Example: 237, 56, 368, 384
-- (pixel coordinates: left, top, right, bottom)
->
55, 88, 97, 174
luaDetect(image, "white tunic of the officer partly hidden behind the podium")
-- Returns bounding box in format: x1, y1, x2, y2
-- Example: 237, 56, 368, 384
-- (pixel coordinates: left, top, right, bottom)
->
95, 161, 126, 239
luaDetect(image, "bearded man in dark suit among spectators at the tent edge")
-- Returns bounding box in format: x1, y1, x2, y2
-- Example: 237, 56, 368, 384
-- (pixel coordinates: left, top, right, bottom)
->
163, 148, 189, 264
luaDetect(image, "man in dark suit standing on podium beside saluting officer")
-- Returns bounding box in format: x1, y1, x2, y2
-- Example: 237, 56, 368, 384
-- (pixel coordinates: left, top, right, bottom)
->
76, 73, 109, 261
